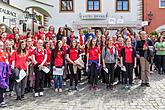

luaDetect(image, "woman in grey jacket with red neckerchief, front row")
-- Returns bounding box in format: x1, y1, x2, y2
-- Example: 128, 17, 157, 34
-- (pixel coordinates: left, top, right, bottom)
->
102, 38, 118, 89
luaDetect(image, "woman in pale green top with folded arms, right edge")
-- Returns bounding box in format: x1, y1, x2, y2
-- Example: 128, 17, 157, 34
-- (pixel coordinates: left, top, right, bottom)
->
155, 36, 165, 74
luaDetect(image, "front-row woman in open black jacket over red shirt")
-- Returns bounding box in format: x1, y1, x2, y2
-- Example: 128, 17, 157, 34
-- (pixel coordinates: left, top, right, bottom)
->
121, 37, 136, 89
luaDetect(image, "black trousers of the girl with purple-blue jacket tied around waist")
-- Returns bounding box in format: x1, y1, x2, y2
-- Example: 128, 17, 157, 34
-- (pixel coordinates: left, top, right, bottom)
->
90, 63, 98, 85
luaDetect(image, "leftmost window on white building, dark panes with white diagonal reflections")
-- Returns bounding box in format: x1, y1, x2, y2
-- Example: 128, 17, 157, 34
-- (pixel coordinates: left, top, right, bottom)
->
61, 0, 73, 11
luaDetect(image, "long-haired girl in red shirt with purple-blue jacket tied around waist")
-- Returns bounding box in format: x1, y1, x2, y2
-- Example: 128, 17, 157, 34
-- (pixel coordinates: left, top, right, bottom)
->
87, 38, 101, 90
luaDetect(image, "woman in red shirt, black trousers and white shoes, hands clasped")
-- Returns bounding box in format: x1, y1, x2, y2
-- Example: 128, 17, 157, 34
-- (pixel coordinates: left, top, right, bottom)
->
32, 39, 47, 97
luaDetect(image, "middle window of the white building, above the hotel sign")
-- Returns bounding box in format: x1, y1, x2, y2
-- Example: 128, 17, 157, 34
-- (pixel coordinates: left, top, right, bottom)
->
87, 0, 100, 11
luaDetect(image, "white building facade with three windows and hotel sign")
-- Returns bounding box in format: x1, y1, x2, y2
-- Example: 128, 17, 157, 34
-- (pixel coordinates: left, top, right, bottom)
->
52, 0, 142, 34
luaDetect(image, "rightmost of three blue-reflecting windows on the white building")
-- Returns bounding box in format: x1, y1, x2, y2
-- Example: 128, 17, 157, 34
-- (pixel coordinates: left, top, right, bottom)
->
116, 0, 129, 11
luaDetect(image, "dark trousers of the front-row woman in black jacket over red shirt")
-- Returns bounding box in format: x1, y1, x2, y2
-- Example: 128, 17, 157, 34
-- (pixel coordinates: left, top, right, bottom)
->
124, 63, 133, 85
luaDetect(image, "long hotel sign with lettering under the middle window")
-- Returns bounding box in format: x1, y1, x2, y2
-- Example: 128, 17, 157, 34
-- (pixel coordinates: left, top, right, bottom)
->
79, 13, 108, 20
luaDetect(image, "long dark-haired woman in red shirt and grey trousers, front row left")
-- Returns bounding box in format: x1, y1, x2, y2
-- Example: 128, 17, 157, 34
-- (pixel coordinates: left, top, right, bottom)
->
12, 41, 28, 100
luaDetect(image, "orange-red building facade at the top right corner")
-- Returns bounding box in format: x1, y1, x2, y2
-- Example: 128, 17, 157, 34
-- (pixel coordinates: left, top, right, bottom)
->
144, 0, 165, 32
